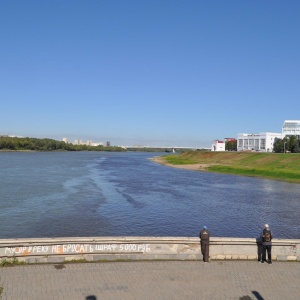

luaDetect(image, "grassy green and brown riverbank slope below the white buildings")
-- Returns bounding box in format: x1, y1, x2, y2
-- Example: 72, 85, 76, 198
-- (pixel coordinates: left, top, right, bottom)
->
164, 151, 300, 183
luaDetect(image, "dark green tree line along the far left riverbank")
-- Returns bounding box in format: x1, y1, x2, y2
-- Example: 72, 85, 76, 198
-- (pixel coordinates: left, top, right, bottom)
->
0, 136, 124, 151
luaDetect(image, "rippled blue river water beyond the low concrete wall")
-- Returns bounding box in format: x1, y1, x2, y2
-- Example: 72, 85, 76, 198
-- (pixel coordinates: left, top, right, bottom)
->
0, 152, 300, 239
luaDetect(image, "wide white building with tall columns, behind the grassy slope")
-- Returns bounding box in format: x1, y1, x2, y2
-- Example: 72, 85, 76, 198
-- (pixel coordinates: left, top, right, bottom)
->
237, 132, 282, 152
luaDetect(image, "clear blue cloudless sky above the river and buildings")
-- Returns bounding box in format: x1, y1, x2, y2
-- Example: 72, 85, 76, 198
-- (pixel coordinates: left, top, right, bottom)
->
0, 0, 300, 147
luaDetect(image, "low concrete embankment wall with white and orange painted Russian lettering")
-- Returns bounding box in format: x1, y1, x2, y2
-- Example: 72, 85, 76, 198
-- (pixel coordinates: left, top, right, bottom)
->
0, 237, 300, 263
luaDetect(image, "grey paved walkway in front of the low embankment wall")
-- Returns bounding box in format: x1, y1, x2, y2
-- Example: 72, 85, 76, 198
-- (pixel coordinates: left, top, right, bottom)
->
0, 261, 300, 300
